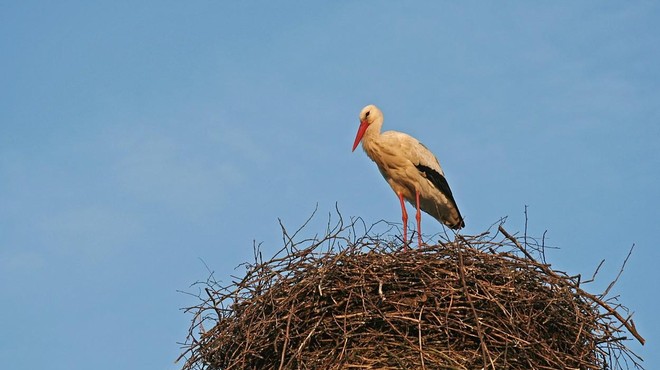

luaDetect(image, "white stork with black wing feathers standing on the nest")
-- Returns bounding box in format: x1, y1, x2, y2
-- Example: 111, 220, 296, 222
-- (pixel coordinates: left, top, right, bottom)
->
353, 105, 465, 246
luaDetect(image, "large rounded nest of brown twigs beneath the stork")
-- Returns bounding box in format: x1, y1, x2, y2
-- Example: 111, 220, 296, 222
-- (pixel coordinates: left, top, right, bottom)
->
181, 215, 643, 370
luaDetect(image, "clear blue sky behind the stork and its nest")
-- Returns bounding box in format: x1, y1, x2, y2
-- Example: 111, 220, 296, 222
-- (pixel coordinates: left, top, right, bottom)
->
0, 1, 660, 370
